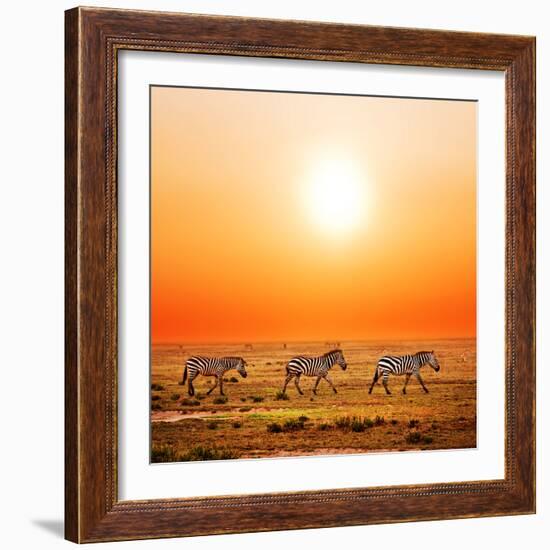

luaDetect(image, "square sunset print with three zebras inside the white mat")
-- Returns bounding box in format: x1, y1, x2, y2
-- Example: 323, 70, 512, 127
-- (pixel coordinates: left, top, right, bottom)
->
150, 86, 477, 462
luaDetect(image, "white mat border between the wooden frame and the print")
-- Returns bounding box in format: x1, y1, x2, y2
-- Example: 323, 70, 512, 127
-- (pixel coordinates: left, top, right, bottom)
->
118, 51, 505, 500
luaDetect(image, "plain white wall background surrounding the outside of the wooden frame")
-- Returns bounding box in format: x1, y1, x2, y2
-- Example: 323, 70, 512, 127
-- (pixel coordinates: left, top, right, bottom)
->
0, 0, 550, 550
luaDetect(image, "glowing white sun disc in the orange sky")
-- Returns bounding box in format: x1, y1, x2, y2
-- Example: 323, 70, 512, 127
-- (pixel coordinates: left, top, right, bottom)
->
306, 159, 364, 235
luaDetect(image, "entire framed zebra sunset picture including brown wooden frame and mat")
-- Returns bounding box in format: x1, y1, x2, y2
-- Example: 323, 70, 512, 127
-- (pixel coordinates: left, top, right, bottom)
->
65, 8, 535, 542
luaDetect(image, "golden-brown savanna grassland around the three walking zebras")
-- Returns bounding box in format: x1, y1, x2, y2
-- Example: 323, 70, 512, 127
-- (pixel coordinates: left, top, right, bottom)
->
151, 339, 476, 462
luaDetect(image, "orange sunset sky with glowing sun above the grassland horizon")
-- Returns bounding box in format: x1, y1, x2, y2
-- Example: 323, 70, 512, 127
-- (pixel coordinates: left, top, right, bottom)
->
151, 86, 477, 343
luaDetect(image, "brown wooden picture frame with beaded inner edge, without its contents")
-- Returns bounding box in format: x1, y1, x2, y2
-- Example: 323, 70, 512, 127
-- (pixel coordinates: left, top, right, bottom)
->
65, 8, 535, 542
